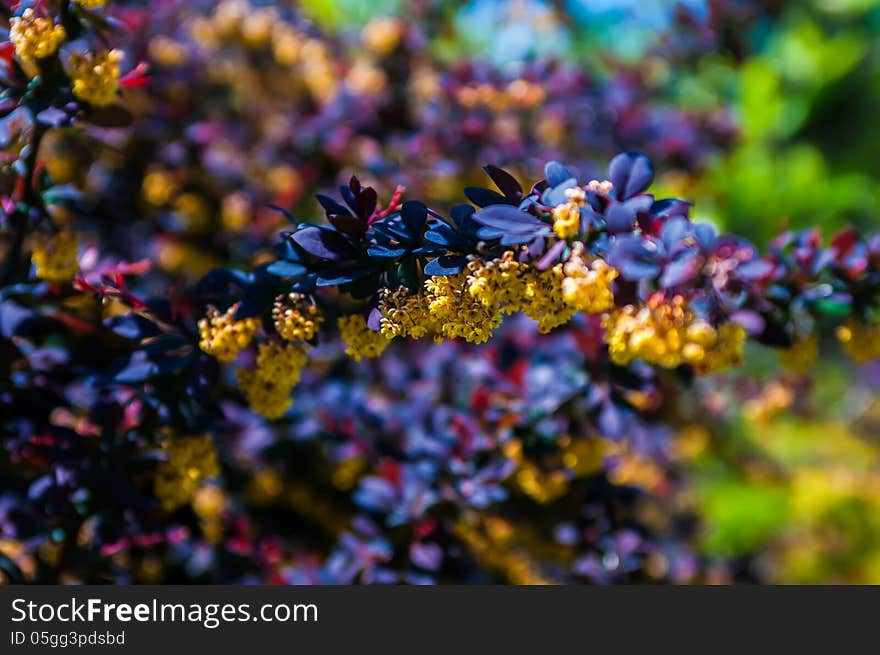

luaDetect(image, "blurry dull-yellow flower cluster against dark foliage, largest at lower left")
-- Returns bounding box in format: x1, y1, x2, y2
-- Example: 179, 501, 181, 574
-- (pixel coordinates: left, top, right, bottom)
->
155, 434, 220, 511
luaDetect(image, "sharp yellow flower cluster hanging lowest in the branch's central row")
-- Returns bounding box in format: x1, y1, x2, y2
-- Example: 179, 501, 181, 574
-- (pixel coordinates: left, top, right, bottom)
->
425, 268, 502, 343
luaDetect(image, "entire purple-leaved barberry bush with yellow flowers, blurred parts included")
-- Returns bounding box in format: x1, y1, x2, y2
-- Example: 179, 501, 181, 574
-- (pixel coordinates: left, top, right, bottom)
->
0, 0, 880, 584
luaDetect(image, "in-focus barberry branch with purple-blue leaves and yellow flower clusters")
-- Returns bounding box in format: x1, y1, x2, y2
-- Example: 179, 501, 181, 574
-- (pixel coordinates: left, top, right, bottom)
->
202, 153, 880, 418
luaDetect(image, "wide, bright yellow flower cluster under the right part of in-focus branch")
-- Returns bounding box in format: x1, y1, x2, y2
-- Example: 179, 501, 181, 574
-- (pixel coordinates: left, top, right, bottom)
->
605, 294, 746, 375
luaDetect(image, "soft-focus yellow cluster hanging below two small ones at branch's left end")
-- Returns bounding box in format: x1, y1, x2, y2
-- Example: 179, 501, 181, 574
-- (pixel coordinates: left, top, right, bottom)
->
236, 341, 308, 419
